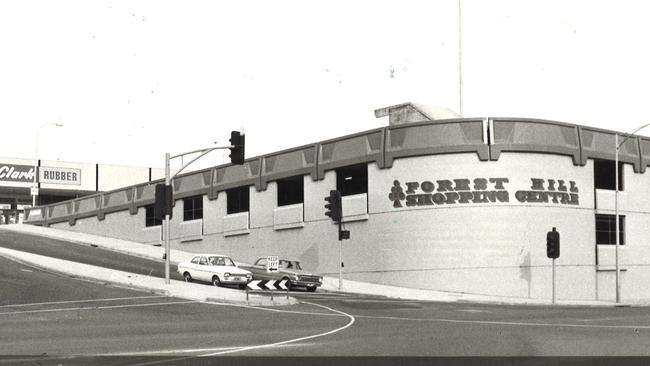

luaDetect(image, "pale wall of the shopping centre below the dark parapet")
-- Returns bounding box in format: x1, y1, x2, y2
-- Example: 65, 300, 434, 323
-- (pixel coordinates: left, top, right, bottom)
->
44, 153, 650, 299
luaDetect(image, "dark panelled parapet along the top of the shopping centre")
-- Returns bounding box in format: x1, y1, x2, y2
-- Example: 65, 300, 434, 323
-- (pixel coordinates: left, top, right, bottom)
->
25, 118, 650, 226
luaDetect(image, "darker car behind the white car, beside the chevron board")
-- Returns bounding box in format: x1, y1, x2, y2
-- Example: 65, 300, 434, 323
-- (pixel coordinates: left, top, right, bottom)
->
242, 257, 323, 292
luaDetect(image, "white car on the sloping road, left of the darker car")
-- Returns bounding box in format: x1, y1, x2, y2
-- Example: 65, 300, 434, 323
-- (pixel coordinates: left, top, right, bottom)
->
177, 254, 253, 289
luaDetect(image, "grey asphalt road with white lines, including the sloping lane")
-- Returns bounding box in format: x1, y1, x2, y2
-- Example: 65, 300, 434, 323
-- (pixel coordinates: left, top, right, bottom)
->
0, 229, 650, 364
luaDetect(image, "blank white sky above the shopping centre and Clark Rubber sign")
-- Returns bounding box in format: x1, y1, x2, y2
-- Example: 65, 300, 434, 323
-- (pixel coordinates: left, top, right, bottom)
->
0, 0, 650, 167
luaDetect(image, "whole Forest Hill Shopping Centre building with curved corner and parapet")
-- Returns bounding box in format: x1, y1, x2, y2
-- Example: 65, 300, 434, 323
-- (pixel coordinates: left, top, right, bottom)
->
26, 103, 650, 301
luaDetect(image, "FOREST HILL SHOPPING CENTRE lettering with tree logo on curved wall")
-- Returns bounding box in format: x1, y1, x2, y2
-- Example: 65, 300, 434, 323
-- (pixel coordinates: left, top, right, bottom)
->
388, 178, 579, 208
